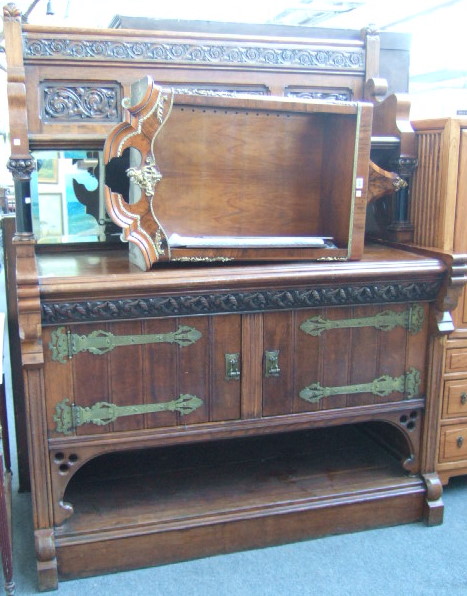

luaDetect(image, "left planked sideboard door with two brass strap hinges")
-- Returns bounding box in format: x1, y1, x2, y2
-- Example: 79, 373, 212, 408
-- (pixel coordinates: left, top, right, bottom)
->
43, 315, 241, 436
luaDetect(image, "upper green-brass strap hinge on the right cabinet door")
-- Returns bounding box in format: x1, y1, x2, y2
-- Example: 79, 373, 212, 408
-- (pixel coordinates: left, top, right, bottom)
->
300, 304, 424, 336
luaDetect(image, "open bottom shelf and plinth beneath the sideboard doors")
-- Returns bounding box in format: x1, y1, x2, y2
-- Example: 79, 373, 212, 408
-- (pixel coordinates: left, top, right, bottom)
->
55, 425, 426, 578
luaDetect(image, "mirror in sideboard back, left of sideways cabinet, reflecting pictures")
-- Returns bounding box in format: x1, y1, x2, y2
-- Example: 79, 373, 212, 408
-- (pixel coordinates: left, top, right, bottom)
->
31, 149, 121, 244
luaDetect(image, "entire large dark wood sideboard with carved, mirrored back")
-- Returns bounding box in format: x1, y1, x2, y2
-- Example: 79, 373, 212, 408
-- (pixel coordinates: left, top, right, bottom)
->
4, 5, 465, 590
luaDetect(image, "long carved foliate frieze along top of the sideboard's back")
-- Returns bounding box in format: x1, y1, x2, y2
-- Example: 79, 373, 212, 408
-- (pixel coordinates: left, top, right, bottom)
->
24, 37, 365, 71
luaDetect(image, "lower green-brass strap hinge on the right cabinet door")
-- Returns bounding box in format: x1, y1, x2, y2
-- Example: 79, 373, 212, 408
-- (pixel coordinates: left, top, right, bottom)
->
299, 368, 420, 403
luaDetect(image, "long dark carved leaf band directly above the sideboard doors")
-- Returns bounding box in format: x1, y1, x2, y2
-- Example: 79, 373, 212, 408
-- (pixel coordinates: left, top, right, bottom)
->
42, 281, 441, 325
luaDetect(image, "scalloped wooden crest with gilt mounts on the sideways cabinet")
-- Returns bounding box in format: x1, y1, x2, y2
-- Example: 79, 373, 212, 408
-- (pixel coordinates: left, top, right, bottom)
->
104, 77, 172, 269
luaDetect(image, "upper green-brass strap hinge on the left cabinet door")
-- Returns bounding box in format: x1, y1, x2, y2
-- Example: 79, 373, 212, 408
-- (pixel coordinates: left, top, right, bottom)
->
49, 325, 202, 363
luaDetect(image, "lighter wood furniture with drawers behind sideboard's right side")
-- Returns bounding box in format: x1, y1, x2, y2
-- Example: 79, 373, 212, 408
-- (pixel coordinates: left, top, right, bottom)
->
411, 118, 467, 483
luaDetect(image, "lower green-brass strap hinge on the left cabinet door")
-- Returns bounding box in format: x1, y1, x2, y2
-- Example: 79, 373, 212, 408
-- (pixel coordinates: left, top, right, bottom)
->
53, 393, 204, 435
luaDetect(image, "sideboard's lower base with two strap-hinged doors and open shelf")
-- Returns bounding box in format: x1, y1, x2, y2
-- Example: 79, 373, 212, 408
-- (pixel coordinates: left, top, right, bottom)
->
14, 245, 447, 588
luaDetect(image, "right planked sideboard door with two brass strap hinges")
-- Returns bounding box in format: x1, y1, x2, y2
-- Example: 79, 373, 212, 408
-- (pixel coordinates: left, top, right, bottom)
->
263, 304, 427, 416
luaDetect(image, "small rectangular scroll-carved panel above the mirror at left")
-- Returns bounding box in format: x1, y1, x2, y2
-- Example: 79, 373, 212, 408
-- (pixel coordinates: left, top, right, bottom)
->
41, 81, 122, 122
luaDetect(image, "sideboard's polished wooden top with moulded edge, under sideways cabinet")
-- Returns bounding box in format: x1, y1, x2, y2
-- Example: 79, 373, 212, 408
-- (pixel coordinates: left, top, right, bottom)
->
37, 245, 446, 299
